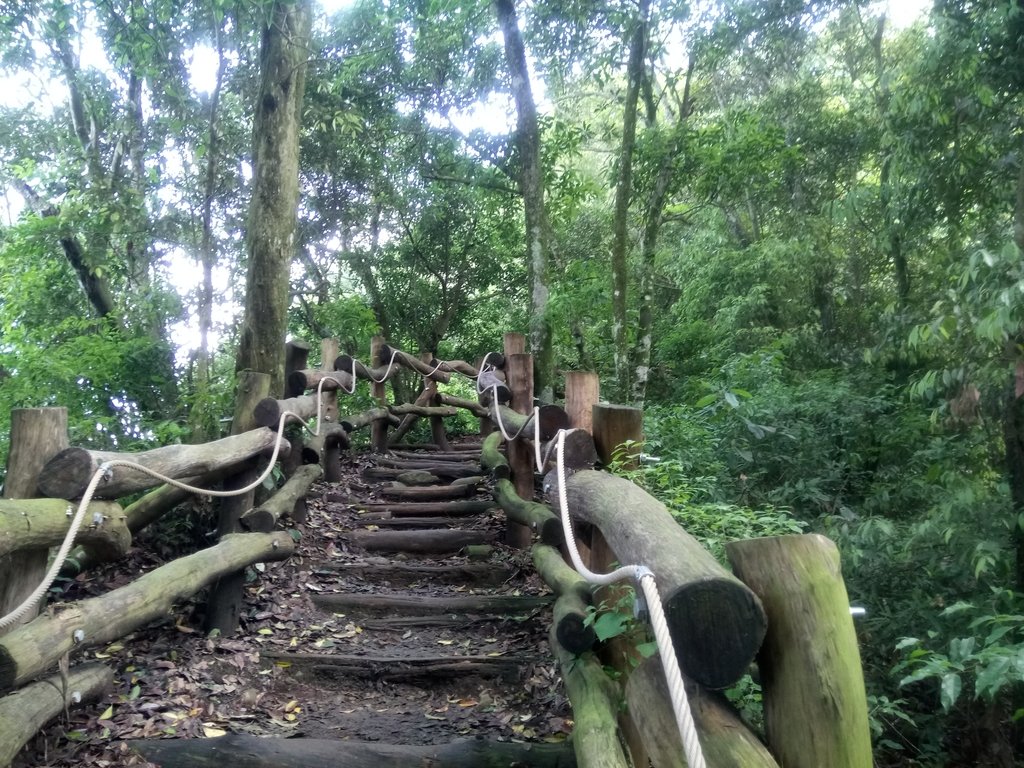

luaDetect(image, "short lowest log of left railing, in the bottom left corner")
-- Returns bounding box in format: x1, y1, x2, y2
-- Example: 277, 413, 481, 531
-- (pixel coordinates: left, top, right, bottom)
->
0, 664, 114, 766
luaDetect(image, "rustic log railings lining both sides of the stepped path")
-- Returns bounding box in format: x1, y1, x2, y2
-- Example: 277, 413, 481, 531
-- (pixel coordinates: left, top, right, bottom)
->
0, 334, 870, 768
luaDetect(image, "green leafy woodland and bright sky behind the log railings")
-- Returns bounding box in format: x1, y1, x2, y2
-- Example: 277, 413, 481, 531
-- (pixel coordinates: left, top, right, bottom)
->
0, 0, 1024, 766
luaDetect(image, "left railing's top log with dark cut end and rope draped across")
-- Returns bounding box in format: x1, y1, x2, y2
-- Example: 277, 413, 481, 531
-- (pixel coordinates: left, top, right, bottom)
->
39, 427, 288, 499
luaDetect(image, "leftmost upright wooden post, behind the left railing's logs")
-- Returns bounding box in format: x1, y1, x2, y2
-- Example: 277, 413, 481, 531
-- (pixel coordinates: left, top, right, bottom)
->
0, 408, 68, 635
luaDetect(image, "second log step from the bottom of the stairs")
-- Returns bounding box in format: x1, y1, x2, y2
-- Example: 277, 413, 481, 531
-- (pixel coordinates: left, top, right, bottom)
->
260, 651, 524, 681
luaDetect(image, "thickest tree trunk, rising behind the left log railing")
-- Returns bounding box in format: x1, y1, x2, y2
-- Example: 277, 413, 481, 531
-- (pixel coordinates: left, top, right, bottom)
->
236, 0, 312, 392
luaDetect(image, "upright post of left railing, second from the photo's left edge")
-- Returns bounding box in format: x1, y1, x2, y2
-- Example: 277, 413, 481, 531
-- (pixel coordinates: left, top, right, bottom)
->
206, 371, 270, 635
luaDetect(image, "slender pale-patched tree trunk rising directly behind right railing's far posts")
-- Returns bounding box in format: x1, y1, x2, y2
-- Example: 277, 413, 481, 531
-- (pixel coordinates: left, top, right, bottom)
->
495, 0, 554, 402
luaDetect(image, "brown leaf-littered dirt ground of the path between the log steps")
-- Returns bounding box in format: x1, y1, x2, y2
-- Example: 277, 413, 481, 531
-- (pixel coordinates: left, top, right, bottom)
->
13, 444, 571, 768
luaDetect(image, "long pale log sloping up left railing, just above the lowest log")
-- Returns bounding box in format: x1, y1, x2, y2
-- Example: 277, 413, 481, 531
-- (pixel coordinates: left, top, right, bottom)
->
0, 534, 295, 690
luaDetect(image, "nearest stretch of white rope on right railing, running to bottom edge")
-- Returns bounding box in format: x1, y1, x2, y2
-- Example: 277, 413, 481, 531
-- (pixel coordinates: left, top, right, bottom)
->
555, 429, 707, 768
